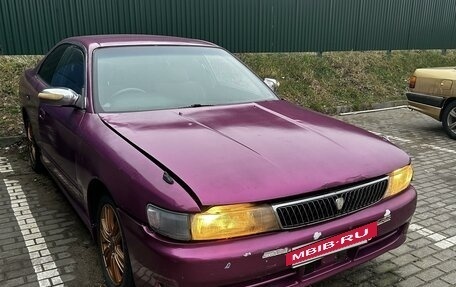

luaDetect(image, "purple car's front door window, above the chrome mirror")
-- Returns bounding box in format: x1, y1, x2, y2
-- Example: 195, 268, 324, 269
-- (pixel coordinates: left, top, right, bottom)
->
50, 46, 84, 94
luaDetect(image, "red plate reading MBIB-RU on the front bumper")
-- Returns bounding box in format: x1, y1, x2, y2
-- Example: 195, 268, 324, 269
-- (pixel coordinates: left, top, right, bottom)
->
286, 222, 377, 267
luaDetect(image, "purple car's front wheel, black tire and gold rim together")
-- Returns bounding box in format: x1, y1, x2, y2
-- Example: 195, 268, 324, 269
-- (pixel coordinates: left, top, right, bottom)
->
96, 196, 134, 287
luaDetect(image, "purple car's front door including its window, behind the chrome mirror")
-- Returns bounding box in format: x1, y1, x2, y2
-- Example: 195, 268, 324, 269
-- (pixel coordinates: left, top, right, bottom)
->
38, 45, 85, 204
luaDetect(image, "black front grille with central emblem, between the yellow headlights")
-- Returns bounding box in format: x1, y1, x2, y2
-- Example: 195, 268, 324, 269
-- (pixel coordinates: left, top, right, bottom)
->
272, 177, 388, 229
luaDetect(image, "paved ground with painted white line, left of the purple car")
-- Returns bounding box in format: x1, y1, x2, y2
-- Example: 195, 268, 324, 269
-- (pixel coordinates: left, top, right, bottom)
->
0, 150, 103, 287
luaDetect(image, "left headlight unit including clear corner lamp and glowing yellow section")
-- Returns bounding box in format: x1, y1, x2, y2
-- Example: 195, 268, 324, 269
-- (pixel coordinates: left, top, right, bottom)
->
147, 204, 279, 241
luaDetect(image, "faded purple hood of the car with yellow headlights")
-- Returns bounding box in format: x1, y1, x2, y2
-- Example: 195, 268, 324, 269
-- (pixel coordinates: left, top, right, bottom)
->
100, 101, 410, 206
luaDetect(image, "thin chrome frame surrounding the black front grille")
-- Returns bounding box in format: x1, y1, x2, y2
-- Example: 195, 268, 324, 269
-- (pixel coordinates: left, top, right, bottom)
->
271, 176, 389, 230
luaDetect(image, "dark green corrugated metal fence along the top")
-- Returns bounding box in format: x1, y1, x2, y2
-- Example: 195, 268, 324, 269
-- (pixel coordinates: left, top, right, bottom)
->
0, 0, 456, 54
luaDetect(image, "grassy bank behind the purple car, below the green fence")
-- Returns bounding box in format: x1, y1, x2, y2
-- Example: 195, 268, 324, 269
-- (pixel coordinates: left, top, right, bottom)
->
0, 50, 456, 136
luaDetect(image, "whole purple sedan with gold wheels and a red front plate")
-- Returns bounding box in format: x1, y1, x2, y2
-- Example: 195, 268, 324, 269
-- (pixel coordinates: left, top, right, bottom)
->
20, 35, 416, 287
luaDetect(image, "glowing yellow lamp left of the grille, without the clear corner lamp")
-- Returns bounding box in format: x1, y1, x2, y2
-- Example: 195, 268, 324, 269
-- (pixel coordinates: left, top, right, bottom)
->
191, 204, 279, 240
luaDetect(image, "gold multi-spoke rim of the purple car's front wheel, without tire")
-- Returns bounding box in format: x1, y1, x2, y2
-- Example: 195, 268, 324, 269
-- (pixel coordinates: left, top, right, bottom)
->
99, 204, 125, 286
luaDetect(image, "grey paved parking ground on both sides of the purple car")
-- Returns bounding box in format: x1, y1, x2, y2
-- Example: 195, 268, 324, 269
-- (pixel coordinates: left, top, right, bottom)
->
0, 109, 456, 287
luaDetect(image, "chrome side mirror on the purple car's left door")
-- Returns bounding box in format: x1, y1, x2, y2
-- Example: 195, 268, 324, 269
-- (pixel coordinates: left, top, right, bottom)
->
38, 88, 85, 109
